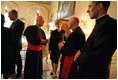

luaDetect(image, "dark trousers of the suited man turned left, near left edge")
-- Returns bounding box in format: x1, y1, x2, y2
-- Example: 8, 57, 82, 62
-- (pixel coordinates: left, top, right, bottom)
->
10, 50, 22, 75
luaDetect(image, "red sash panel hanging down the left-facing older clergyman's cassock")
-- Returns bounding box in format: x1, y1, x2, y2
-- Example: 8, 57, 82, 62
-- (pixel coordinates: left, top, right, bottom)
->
61, 56, 73, 79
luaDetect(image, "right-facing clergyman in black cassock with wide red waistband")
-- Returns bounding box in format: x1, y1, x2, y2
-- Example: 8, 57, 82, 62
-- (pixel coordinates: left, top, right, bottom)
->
24, 16, 48, 79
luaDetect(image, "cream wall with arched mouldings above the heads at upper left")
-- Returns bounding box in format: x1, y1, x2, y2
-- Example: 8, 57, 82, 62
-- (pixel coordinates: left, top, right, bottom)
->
1, 1, 50, 27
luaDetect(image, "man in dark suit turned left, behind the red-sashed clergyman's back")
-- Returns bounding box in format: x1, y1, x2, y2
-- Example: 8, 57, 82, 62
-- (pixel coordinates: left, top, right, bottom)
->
9, 10, 24, 78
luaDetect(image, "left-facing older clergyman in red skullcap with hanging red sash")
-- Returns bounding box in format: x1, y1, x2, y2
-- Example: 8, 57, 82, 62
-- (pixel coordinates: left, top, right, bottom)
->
59, 17, 85, 79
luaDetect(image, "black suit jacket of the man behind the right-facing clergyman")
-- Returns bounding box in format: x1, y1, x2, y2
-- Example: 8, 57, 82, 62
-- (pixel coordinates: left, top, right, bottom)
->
10, 19, 24, 50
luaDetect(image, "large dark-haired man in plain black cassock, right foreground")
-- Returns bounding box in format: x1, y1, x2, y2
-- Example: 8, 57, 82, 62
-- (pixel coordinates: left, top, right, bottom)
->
73, 1, 117, 79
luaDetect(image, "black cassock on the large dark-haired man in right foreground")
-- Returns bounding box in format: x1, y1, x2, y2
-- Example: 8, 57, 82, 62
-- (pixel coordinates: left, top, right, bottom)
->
76, 15, 117, 78
